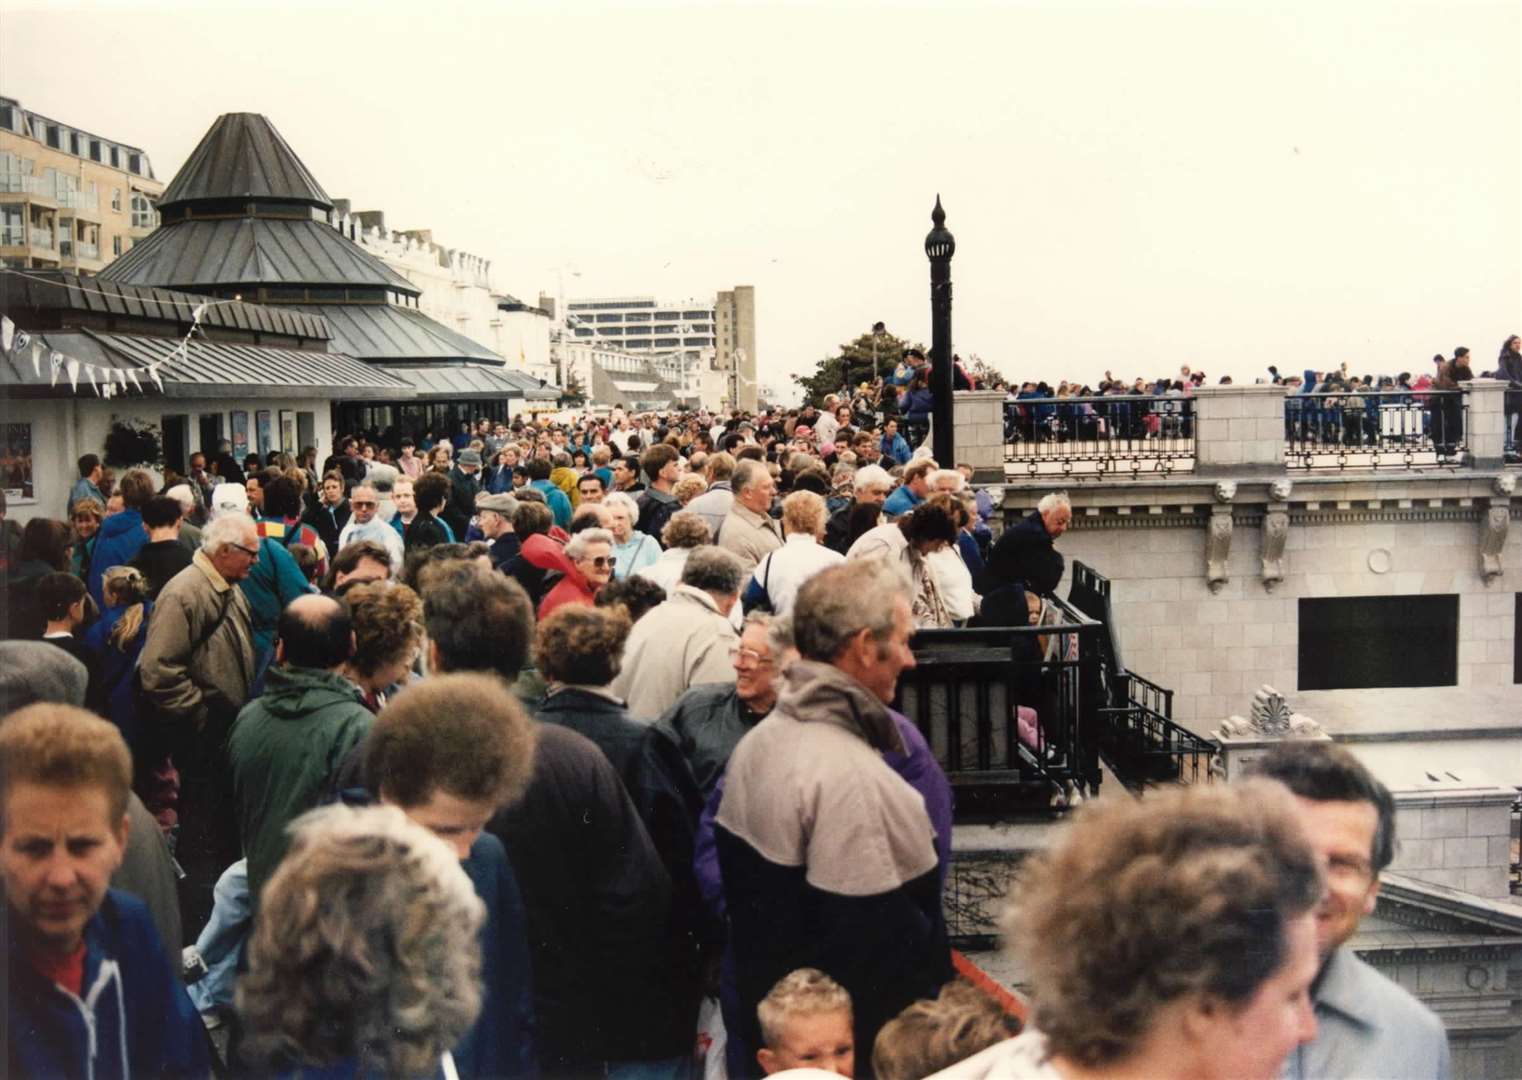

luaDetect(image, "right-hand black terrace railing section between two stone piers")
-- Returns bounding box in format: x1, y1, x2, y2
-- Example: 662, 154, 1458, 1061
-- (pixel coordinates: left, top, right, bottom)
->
1285, 389, 1469, 469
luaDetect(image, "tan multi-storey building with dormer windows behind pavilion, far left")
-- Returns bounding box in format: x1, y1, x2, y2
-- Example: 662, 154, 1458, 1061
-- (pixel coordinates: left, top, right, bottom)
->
0, 97, 164, 274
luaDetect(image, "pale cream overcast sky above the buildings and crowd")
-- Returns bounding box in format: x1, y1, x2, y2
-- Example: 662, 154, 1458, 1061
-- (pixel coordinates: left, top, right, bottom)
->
0, 0, 1522, 401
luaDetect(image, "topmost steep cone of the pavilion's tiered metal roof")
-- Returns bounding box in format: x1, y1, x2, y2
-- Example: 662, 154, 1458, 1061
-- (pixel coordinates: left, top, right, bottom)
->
158, 113, 333, 210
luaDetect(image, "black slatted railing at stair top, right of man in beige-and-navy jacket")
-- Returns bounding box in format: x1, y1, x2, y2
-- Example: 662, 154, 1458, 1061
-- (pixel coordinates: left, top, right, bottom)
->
895, 617, 1105, 817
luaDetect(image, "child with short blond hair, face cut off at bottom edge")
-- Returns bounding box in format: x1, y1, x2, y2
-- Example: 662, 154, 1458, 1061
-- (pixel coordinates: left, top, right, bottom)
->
756, 967, 855, 1077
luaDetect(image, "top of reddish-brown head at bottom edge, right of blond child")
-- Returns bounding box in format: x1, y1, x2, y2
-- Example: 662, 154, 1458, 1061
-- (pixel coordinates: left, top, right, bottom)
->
872, 978, 1020, 1080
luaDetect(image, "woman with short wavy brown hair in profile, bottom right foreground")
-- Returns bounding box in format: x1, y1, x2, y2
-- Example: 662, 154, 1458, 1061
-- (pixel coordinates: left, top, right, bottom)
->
935, 780, 1324, 1080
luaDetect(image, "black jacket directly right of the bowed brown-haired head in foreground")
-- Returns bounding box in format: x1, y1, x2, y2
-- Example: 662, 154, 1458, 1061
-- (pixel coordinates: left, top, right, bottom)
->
487, 724, 696, 1077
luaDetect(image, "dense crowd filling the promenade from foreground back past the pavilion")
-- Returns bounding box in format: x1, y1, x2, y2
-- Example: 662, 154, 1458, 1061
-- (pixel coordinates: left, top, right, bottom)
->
0, 400, 1446, 1078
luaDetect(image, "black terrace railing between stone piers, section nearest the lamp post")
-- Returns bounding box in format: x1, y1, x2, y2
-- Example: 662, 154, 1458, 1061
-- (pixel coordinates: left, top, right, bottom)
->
1005, 394, 1195, 476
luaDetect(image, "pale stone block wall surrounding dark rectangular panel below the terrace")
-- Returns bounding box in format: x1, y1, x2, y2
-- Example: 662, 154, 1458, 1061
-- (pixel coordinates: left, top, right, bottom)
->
1041, 485, 1522, 732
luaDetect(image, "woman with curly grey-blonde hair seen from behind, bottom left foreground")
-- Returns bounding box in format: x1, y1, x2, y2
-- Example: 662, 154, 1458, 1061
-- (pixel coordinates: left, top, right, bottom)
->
237, 806, 486, 1077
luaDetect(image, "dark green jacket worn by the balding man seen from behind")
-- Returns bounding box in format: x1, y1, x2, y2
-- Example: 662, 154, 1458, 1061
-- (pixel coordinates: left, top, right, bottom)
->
227, 665, 373, 899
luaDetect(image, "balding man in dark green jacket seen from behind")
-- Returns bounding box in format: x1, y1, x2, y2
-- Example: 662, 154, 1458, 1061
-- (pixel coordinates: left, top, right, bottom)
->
227, 593, 373, 904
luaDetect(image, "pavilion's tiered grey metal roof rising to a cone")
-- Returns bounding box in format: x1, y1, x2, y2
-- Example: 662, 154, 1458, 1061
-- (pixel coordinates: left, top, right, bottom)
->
99, 113, 556, 432
